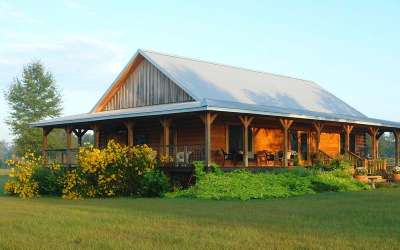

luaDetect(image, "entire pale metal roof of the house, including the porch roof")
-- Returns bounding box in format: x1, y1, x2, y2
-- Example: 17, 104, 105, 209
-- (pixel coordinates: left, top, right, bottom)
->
32, 50, 400, 128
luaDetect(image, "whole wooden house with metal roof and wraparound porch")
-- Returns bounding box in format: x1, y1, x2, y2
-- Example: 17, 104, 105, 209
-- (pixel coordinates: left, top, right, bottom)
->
33, 50, 400, 173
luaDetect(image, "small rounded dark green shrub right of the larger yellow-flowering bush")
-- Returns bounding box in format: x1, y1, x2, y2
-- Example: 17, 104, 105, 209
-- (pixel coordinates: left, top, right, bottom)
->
139, 170, 169, 197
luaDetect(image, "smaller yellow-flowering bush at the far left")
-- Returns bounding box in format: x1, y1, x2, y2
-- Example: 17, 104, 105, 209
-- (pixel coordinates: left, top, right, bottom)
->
4, 153, 42, 199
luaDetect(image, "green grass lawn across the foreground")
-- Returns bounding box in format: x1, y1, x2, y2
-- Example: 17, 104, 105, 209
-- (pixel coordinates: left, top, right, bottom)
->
0, 189, 400, 249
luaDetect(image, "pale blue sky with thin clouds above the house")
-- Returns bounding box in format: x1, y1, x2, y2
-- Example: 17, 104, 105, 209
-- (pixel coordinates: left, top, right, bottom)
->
0, 0, 400, 141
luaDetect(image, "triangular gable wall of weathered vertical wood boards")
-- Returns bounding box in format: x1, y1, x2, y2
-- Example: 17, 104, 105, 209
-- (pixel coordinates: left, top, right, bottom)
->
105, 60, 194, 110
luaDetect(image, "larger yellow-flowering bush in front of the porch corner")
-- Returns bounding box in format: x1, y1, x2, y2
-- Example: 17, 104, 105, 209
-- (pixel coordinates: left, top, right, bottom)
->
62, 141, 156, 199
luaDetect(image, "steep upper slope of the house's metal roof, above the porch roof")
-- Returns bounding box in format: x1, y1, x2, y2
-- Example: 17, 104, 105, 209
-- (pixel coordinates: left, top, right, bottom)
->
139, 50, 366, 118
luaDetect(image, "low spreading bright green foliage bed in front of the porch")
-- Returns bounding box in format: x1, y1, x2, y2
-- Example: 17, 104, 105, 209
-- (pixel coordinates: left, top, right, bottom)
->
167, 164, 369, 200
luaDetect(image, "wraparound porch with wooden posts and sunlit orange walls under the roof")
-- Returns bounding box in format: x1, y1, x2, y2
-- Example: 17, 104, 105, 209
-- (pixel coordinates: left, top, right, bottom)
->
43, 112, 399, 176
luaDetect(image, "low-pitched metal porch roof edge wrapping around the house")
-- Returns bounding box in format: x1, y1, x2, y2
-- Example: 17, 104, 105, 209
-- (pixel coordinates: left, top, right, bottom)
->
31, 100, 400, 129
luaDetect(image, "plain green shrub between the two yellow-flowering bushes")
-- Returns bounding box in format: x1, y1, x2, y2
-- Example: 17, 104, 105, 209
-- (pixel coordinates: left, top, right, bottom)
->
31, 167, 62, 195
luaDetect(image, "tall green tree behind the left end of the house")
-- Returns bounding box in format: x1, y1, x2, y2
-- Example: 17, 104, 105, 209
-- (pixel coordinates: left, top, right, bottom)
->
5, 61, 62, 155
